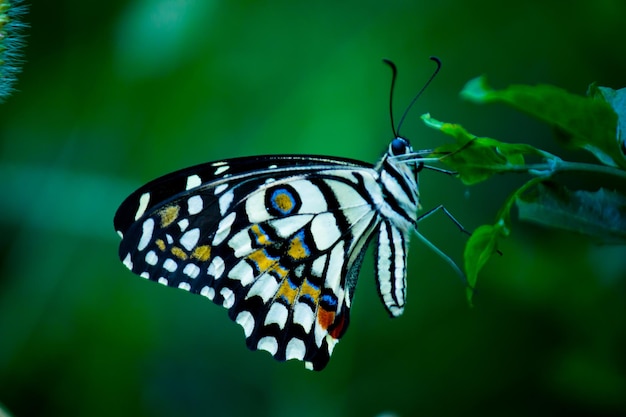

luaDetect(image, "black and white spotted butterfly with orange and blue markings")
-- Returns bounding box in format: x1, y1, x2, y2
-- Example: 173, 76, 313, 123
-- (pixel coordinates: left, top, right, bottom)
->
114, 57, 458, 370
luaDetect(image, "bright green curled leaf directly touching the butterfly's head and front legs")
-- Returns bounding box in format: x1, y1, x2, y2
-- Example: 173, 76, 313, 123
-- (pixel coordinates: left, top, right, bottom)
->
422, 114, 555, 185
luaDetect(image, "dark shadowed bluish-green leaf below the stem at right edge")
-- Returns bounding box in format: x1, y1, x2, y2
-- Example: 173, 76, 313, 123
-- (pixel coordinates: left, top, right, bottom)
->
516, 182, 626, 244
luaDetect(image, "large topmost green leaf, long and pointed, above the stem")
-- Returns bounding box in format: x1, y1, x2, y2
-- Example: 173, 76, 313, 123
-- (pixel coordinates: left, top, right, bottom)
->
461, 77, 626, 168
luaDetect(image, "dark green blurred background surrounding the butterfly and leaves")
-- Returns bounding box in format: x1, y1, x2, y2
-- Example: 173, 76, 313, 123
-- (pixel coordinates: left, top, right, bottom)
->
0, 0, 626, 417
